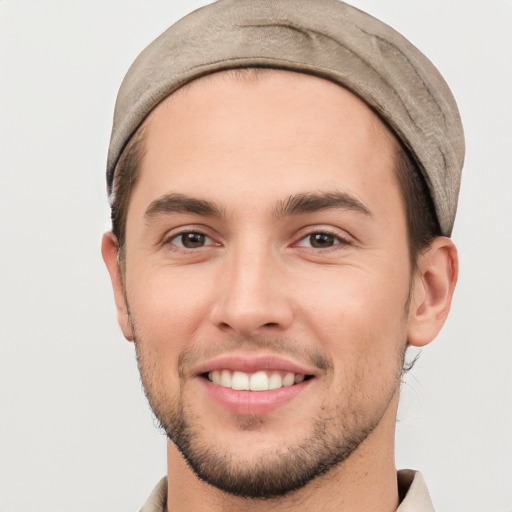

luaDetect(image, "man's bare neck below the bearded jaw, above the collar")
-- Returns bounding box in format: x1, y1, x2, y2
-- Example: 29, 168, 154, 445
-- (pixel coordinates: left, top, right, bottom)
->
167, 400, 399, 512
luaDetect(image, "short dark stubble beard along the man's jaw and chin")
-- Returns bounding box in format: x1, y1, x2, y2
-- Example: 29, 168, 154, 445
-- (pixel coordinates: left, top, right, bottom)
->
133, 326, 405, 500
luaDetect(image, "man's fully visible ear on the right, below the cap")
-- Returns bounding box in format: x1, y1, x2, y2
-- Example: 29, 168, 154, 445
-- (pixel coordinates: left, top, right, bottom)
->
407, 237, 459, 347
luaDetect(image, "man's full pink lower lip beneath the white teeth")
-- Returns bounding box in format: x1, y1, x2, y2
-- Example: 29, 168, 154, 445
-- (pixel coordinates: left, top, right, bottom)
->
201, 378, 314, 416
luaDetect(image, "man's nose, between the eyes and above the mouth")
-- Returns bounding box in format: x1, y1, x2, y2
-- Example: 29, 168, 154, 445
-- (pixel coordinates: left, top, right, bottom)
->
211, 245, 293, 336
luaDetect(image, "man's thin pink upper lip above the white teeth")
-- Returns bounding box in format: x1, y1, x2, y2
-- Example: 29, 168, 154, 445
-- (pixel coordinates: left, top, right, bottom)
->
193, 354, 318, 376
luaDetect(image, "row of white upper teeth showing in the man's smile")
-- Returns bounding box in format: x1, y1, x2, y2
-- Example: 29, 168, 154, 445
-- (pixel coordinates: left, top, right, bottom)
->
208, 369, 305, 391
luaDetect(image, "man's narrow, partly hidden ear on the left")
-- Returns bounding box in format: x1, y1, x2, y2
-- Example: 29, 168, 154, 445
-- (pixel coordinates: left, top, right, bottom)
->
101, 231, 133, 341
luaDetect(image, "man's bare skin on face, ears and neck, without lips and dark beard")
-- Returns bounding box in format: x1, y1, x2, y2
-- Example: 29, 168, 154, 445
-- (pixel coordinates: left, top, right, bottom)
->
102, 72, 457, 511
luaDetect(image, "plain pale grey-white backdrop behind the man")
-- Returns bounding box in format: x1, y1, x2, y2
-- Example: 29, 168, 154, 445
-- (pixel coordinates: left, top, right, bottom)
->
0, 0, 512, 512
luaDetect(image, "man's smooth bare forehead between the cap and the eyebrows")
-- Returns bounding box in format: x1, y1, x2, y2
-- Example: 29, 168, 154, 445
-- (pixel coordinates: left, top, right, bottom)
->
128, 69, 397, 216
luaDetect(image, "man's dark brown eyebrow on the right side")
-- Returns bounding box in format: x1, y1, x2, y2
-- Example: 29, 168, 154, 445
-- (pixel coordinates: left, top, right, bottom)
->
273, 192, 373, 218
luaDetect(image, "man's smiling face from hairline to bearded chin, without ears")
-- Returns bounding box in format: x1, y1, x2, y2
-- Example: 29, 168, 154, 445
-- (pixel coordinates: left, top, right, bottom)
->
116, 72, 411, 497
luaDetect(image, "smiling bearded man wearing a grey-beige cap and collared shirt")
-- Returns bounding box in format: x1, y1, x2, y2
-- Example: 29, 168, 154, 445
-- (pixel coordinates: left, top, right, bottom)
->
102, 0, 464, 512
